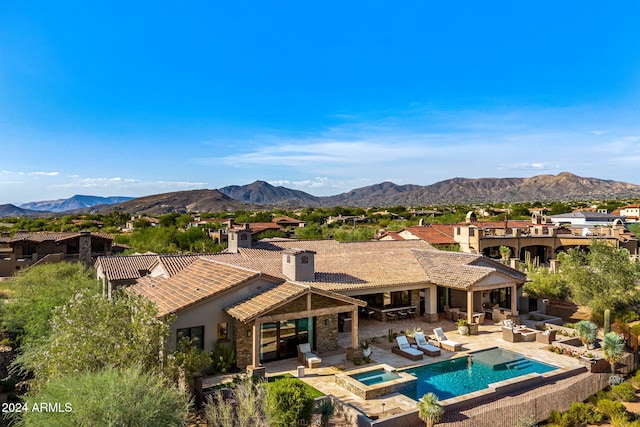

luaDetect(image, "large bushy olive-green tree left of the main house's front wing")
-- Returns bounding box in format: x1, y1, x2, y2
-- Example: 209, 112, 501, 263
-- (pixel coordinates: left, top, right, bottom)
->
16, 292, 170, 387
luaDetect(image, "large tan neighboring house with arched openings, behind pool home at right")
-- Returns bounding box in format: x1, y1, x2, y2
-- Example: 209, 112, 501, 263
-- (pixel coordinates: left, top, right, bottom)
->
454, 216, 638, 264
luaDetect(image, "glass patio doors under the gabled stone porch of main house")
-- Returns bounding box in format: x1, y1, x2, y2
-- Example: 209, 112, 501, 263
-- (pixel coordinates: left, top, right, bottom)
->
260, 318, 312, 362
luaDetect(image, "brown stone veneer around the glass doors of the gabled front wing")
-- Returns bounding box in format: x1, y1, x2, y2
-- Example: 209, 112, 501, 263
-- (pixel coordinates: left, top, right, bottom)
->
234, 295, 350, 368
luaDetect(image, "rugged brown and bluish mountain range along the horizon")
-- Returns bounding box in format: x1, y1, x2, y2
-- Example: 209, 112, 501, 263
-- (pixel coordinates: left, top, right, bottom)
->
0, 172, 640, 217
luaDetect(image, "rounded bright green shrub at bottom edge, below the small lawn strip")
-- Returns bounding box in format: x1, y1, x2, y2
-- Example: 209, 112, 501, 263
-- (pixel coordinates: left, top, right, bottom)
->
267, 378, 313, 427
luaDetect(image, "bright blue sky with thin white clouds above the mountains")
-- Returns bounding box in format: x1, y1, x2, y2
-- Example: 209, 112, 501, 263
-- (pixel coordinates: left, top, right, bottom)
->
0, 0, 640, 204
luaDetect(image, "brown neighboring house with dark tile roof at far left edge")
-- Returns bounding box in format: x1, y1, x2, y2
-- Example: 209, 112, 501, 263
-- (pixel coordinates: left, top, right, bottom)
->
0, 231, 113, 277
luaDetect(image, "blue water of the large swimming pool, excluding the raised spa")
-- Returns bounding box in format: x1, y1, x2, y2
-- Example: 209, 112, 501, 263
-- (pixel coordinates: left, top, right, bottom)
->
403, 348, 557, 400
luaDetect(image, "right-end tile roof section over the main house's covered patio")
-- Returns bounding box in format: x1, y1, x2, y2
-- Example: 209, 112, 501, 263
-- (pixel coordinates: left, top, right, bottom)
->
413, 250, 527, 290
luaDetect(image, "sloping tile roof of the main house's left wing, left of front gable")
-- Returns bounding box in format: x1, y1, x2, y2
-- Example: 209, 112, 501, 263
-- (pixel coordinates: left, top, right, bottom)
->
130, 258, 260, 316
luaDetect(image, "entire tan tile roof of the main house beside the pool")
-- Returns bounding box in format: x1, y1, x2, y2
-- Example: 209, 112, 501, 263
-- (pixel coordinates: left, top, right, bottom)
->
127, 240, 526, 319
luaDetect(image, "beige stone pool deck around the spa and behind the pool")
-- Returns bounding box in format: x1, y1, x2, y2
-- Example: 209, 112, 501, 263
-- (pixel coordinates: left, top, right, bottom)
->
265, 319, 583, 422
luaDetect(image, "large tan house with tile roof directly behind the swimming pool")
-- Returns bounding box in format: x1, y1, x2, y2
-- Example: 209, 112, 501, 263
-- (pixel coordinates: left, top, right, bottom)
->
98, 229, 526, 367
